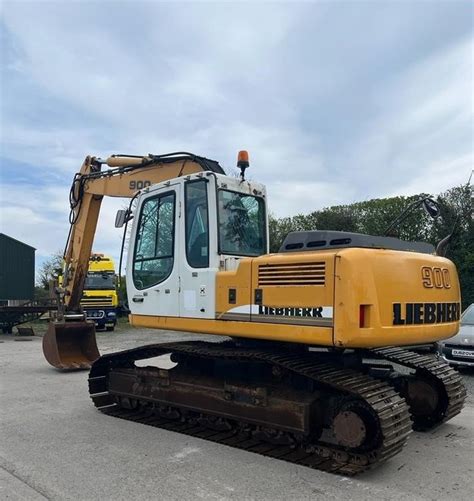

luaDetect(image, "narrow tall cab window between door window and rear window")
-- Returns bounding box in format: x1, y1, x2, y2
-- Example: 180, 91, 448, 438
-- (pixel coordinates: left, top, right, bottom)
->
184, 179, 209, 268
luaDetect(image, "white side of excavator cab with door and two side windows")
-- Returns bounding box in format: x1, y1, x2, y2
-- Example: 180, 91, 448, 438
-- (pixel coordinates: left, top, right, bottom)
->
127, 172, 268, 318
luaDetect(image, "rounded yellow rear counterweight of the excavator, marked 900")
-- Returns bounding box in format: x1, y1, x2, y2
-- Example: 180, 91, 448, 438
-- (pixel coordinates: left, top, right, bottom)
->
334, 249, 461, 348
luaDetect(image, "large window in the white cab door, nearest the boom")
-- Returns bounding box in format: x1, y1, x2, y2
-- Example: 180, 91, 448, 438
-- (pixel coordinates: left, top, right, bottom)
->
133, 193, 175, 289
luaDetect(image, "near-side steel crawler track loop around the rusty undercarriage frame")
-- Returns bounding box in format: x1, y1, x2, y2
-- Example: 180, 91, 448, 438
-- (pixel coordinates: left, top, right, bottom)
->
89, 342, 412, 475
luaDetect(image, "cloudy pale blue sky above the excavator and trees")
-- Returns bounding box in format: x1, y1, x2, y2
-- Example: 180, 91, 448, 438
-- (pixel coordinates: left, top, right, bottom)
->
0, 0, 474, 274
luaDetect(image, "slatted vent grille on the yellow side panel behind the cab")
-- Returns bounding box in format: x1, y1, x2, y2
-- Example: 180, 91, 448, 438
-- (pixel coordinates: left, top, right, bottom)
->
258, 261, 326, 287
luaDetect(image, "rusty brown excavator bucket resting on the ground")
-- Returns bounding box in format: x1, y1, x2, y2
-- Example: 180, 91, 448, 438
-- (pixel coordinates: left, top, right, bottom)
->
43, 321, 100, 370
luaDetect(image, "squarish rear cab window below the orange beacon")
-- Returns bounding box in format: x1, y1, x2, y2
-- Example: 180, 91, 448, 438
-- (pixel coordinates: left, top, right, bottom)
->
217, 190, 266, 256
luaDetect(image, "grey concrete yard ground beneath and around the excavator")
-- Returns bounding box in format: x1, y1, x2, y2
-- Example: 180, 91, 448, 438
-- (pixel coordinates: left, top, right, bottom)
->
0, 325, 474, 501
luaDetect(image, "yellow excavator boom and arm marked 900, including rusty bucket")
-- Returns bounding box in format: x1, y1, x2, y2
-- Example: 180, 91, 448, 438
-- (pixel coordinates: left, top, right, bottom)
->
43, 152, 224, 370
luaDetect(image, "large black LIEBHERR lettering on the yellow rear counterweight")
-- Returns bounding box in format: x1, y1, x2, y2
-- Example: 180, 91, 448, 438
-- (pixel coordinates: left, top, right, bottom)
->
393, 303, 461, 325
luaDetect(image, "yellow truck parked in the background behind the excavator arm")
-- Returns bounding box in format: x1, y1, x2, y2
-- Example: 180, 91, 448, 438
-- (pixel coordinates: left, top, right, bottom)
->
81, 254, 118, 331
